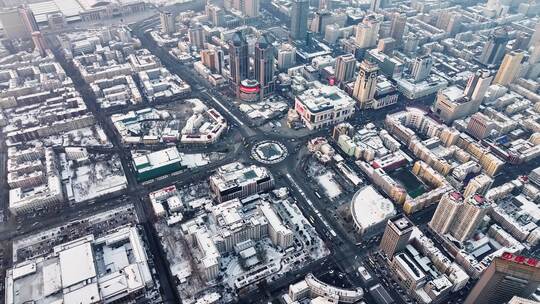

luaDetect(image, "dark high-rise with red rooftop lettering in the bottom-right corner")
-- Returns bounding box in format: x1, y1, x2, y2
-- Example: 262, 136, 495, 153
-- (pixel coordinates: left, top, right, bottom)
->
464, 252, 540, 304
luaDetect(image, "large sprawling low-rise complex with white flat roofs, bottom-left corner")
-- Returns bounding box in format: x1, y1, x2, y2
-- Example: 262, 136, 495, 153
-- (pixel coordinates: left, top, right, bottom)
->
5, 226, 154, 304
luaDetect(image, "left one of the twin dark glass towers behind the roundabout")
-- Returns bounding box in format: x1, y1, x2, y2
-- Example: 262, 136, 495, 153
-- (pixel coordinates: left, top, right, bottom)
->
229, 31, 249, 95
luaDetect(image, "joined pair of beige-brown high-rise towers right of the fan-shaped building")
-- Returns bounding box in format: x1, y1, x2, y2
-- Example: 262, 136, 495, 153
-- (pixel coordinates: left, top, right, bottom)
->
429, 192, 490, 242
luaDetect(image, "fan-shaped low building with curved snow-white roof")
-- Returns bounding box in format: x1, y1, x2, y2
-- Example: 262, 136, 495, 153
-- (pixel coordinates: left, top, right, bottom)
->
351, 186, 396, 238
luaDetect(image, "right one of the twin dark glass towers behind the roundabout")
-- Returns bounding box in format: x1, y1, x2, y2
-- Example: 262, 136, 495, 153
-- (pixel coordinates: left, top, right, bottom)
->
254, 34, 274, 100
